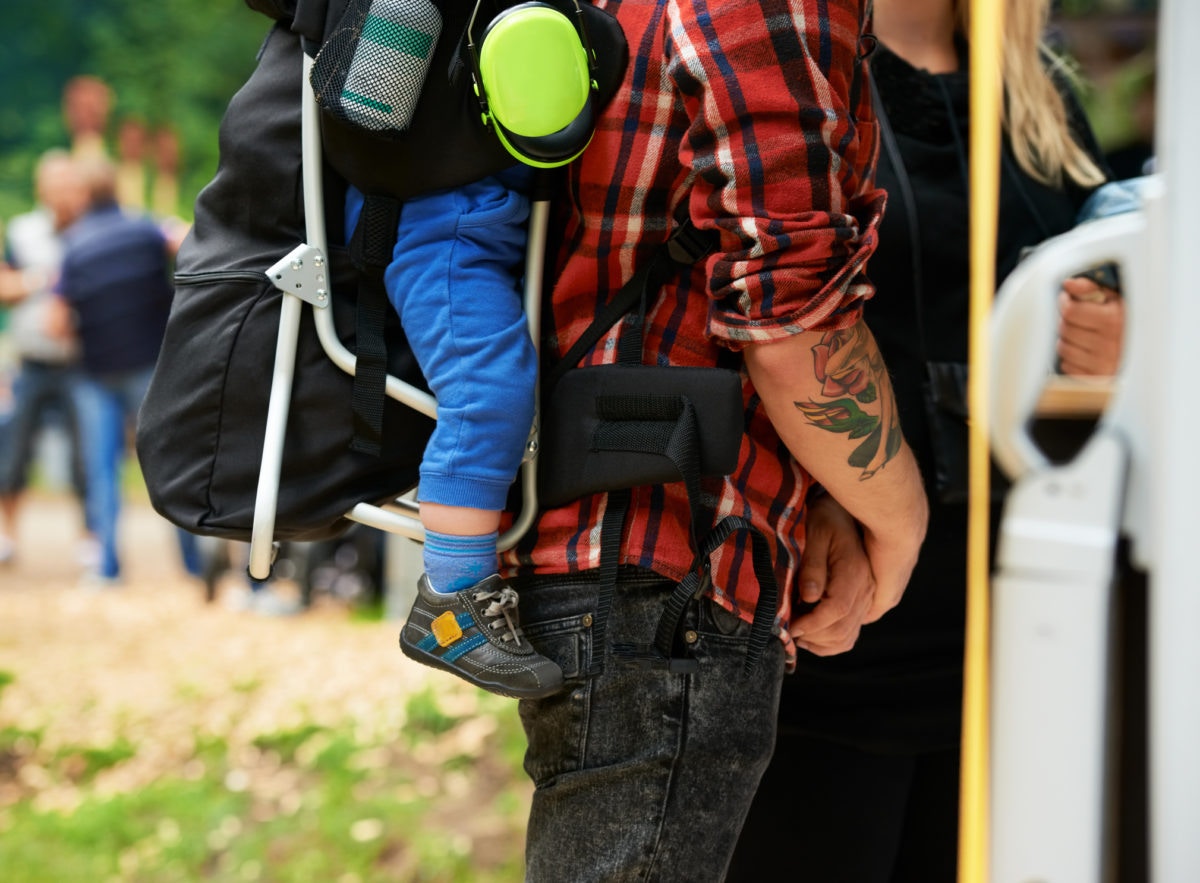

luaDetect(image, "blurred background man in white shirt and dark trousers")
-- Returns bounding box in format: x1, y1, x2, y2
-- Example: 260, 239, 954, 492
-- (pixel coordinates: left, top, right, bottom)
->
0, 150, 88, 563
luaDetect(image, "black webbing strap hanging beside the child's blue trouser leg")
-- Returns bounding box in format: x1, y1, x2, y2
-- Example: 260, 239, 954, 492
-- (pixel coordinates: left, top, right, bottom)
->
350, 196, 401, 456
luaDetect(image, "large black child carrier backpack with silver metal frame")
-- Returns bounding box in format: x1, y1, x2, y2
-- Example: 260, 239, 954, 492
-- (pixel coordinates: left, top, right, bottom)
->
137, 0, 628, 559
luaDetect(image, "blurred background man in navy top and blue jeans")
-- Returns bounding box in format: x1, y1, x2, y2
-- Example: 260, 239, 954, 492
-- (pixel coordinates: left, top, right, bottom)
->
58, 157, 200, 585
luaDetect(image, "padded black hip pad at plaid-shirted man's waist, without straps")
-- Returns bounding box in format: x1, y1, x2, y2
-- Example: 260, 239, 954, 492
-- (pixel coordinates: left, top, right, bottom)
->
538, 364, 745, 507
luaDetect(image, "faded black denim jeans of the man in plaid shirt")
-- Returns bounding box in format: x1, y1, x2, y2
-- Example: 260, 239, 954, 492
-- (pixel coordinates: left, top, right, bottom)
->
518, 570, 784, 883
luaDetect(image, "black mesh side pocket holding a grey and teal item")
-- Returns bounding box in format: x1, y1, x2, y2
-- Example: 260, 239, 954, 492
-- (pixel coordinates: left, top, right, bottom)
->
312, 0, 442, 134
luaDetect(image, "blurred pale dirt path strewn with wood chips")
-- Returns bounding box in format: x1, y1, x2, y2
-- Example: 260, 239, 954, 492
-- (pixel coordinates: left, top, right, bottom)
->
0, 498, 520, 805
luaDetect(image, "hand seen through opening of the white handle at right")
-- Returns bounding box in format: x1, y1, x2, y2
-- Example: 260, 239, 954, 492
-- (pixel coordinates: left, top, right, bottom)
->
1058, 277, 1124, 377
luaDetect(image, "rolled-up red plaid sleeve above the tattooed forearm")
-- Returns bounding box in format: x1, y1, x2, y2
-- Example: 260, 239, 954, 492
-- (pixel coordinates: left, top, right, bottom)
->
668, 0, 886, 349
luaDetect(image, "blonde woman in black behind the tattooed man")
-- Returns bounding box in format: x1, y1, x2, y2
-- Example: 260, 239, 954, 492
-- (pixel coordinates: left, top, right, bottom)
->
728, 0, 1120, 883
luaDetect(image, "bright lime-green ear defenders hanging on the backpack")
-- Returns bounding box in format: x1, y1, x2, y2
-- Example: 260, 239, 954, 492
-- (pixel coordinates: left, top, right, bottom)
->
467, 0, 598, 168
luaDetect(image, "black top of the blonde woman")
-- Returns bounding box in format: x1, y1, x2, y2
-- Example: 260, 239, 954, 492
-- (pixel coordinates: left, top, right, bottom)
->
780, 46, 1098, 752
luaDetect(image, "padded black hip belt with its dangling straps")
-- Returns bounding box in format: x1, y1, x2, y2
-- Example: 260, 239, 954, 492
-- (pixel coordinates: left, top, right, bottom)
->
528, 218, 779, 672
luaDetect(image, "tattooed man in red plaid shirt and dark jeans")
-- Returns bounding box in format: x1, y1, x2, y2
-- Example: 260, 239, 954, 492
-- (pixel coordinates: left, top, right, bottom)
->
508, 0, 926, 883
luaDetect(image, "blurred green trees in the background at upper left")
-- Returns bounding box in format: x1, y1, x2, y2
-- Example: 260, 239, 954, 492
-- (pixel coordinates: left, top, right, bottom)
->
0, 0, 270, 218
